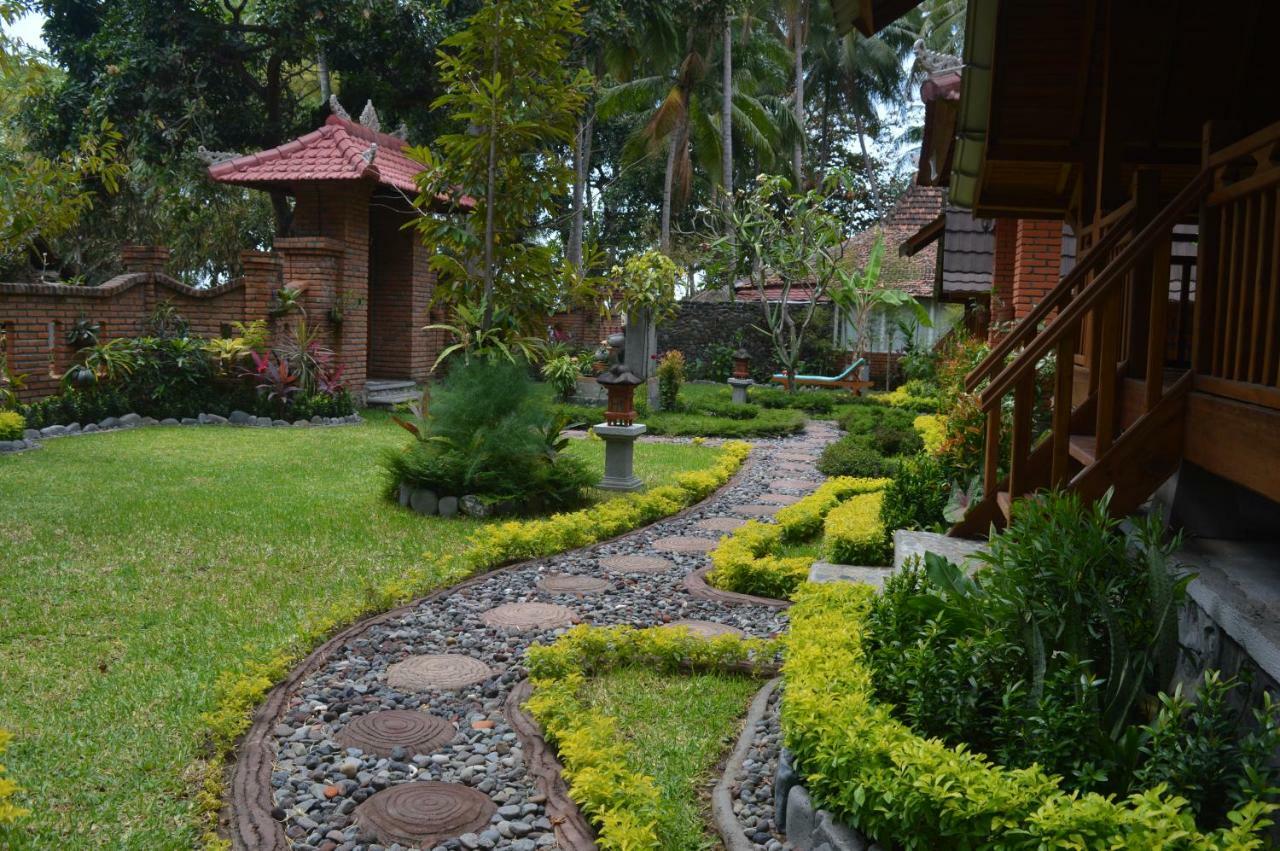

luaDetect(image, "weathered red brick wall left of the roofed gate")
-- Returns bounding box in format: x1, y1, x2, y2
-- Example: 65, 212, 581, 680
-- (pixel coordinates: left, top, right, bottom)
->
0, 246, 279, 401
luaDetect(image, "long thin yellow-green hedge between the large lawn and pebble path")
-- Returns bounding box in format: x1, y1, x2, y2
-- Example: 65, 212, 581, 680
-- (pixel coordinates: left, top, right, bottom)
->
195, 440, 751, 847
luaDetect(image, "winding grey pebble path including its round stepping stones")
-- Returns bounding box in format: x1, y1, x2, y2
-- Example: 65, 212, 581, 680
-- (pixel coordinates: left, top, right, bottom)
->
259, 422, 837, 851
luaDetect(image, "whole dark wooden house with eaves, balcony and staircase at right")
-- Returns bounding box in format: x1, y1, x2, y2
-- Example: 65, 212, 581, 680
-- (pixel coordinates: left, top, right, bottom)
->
833, 0, 1280, 534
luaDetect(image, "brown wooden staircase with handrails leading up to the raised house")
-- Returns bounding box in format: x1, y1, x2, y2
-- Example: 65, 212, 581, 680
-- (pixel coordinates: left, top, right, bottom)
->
951, 161, 1213, 537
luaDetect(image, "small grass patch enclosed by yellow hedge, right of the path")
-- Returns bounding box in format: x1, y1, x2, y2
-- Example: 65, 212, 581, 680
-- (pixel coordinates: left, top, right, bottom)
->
586, 668, 760, 851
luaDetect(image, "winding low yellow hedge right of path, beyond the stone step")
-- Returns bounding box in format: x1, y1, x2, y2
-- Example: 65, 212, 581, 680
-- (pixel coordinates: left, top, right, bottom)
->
707, 476, 888, 600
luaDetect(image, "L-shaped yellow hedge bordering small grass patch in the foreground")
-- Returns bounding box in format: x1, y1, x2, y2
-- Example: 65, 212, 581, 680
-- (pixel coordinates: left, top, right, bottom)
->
526, 626, 777, 851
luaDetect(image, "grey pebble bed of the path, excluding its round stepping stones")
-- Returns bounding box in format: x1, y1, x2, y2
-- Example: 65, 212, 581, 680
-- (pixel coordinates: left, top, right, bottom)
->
228, 422, 837, 851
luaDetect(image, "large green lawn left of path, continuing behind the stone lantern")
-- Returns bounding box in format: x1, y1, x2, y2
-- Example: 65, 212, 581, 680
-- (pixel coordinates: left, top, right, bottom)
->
0, 415, 717, 850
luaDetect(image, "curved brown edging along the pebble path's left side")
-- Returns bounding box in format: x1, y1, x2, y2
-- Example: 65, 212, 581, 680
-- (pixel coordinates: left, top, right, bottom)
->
219, 440, 759, 851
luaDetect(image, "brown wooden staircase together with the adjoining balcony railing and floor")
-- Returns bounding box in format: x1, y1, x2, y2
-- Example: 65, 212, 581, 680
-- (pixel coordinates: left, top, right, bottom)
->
954, 123, 1280, 535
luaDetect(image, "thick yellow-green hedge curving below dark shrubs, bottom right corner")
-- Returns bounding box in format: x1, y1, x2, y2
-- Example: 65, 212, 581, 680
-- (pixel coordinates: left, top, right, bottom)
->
782, 582, 1276, 851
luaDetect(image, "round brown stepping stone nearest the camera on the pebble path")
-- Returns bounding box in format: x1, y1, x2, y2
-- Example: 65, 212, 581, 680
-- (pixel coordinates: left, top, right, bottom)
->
355, 781, 498, 848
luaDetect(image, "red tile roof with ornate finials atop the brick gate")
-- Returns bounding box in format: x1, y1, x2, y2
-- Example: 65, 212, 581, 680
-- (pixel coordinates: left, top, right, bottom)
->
209, 115, 422, 196
